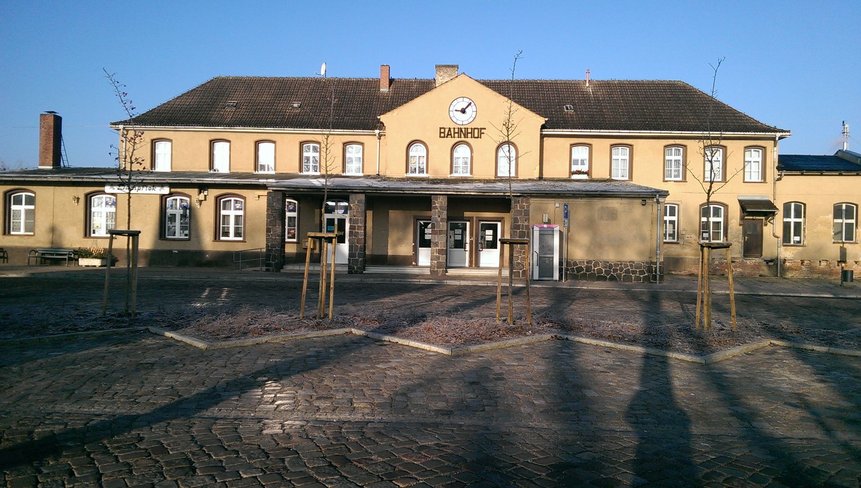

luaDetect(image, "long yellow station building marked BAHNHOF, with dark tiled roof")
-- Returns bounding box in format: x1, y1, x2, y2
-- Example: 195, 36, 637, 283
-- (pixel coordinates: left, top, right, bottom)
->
0, 65, 861, 281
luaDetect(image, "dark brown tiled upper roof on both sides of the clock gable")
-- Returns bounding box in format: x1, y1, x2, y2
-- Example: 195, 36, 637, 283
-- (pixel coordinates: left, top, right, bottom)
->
121, 77, 786, 133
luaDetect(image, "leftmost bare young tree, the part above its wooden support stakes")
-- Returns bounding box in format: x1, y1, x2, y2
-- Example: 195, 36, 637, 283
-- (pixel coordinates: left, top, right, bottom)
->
102, 68, 146, 229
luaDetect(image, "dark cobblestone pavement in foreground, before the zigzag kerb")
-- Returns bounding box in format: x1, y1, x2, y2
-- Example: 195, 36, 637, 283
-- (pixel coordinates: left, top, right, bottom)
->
0, 332, 861, 487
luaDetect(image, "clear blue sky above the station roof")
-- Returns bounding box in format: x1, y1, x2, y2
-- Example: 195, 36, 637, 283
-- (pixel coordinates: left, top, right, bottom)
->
0, 0, 861, 168
